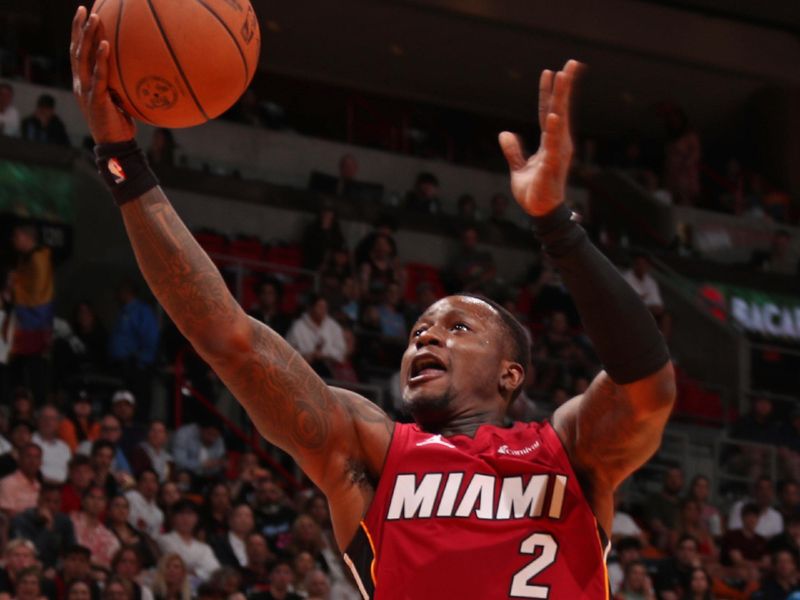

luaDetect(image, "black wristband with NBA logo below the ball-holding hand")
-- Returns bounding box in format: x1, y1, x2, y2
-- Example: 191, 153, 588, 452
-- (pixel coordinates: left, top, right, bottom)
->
94, 140, 158, 206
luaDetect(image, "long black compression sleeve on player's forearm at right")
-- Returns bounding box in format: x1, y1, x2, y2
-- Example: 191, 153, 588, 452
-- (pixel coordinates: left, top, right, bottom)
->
533, 204, 669, 384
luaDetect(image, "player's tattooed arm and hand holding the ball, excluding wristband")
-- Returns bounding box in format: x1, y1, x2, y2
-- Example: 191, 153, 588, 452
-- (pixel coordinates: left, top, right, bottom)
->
70, 7, 392, 544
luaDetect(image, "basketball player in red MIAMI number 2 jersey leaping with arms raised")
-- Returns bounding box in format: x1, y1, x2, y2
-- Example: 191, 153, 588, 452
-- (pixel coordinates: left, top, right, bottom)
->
71, 8, 674, 600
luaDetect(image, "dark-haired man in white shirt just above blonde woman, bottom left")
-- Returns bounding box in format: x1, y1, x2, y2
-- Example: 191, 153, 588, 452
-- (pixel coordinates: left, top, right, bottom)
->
158, 500, 219, 591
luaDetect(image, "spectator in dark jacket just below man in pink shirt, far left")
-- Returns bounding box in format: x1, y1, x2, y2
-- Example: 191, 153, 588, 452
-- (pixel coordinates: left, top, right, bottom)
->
10, 484, 75, 569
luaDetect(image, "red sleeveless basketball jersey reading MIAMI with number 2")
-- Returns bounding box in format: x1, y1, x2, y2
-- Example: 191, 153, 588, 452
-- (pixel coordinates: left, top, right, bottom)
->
345, 423, 609, 600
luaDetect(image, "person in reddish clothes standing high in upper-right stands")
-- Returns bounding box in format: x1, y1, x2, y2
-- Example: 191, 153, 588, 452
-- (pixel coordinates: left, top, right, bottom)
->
664, 106, 702, 205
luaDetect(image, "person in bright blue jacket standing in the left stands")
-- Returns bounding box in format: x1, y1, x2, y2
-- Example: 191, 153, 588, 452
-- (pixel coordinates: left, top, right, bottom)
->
109, 280, 159, 420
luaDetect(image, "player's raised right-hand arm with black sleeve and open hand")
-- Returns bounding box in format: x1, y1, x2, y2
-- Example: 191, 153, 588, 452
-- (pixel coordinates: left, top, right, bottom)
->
500, 61, 675, 531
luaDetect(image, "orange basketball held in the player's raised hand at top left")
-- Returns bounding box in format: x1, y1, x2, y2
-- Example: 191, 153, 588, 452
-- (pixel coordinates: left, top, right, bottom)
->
92, 0, 261, 127
